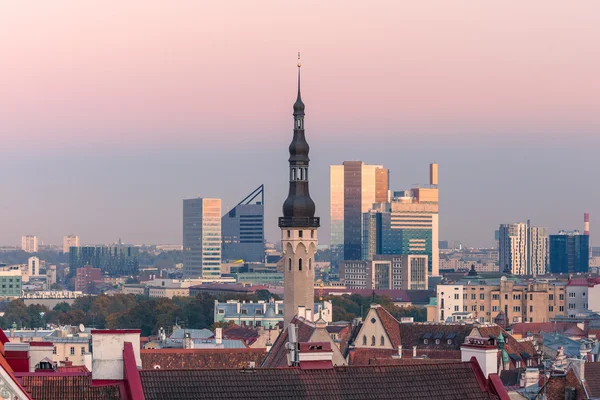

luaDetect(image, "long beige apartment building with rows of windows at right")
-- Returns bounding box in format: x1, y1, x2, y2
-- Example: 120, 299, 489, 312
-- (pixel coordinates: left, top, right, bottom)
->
436, 277, 567, 324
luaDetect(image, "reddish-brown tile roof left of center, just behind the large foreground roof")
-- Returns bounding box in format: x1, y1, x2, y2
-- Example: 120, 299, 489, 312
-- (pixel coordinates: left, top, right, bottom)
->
140, 348, 267, 369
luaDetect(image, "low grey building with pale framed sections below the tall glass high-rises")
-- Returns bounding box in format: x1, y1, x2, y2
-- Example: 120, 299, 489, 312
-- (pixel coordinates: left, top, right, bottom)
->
340, 255, 428, 290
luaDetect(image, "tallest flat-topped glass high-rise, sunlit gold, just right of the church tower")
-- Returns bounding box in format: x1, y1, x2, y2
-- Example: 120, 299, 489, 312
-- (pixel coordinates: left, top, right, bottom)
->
330, 161, 389, 260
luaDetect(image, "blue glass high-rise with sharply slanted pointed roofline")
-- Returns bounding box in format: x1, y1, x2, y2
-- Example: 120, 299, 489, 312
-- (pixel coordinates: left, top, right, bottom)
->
221, 185, 265, 262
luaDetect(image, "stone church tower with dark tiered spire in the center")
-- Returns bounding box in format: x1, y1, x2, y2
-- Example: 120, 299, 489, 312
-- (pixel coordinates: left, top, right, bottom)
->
279, 57, 319, 325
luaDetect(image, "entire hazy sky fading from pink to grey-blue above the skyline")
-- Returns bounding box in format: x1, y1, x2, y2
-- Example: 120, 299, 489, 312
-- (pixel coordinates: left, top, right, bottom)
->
0, 0, 600, 246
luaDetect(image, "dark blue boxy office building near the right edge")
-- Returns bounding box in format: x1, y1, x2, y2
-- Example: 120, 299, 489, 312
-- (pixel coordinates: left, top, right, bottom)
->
549, 231, 590, 274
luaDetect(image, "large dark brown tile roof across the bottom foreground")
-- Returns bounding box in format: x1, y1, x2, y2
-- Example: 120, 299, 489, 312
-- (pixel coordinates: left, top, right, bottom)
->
140, 361, 508, 400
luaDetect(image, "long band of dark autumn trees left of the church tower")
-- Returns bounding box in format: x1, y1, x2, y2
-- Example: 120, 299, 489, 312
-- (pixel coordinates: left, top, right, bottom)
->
0, 290, 275, 336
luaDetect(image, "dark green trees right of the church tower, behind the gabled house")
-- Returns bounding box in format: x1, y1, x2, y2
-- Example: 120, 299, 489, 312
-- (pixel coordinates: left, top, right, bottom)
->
325, 294, 427, 322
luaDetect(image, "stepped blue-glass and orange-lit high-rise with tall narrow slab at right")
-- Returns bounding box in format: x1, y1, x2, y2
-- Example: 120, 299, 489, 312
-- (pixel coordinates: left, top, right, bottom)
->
362, 164, 439, 276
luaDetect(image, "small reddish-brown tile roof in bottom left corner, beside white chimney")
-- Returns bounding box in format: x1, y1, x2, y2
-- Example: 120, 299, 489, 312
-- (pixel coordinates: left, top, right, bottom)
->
21, 374, 121, 400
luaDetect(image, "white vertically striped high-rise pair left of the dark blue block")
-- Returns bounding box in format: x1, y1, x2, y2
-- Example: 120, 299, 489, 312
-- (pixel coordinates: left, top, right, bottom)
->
498, 221, 548, 275
